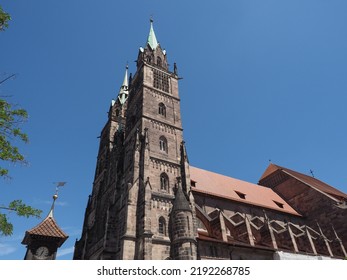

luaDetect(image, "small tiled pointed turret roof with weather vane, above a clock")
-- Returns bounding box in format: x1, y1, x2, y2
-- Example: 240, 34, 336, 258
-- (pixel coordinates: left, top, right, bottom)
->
22, 194, 69, 247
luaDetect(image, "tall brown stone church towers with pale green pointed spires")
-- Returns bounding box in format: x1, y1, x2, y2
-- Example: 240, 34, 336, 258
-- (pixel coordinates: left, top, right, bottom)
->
74, 20, 197, 260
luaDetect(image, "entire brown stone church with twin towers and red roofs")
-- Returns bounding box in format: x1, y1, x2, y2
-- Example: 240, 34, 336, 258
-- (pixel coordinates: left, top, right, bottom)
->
74, 22, 347, 260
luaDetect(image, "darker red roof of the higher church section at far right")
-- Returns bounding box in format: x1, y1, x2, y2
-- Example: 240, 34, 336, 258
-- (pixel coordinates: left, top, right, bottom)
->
259, 163, 347, 199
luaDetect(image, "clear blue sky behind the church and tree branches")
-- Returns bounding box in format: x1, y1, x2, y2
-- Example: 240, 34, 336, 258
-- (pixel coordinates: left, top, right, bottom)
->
0, 0, 347, 259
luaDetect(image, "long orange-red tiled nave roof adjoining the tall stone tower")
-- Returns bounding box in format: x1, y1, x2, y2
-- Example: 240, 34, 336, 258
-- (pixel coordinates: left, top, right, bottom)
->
190, 166, 300, 216
